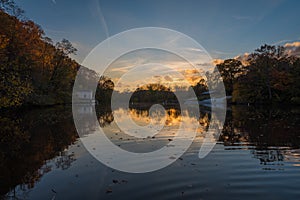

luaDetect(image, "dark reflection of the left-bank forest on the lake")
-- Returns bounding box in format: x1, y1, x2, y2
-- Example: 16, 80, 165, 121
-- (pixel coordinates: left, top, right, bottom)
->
0, 108, 77, 198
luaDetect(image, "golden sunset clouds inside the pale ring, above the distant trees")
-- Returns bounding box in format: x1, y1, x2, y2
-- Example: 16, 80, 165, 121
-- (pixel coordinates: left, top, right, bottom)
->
105, 51, 210, 92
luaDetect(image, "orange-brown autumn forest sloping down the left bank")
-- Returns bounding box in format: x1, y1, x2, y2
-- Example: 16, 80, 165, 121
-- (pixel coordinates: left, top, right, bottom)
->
0, 0, 111, 108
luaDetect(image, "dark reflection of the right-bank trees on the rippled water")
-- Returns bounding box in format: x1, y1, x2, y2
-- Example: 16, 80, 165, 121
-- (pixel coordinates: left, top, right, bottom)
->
219, 106, 300, 164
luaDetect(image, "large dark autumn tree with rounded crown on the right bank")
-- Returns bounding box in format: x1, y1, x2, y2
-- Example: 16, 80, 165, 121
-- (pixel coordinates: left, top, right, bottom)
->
233, 44, 299, 104
